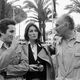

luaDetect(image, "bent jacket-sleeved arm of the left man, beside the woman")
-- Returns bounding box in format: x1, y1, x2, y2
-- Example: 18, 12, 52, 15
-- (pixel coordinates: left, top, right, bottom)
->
7, 45, 29, 75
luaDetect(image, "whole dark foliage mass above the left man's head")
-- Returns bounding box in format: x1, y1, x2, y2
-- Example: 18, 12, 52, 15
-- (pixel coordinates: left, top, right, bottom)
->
0, 0, 27, 23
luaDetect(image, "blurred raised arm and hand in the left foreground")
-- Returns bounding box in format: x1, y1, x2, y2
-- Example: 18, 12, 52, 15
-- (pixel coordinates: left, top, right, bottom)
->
0, 37, 19, 70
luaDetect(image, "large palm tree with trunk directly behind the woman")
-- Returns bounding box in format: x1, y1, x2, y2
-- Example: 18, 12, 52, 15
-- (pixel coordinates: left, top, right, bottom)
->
24, 0, 52, 41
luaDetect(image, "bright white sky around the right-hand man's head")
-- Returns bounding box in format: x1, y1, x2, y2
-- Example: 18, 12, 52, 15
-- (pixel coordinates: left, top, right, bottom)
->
57, 0, 80, 25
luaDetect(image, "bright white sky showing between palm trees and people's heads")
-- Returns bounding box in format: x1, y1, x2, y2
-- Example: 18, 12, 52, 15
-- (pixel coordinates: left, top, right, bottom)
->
9, 0, 80, 38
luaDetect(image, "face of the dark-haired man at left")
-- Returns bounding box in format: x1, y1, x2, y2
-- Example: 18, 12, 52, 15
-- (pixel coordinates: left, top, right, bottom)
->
2, 25, 16, 42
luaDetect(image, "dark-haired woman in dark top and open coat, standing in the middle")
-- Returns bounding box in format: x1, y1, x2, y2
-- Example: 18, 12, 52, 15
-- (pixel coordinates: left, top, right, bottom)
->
23, 23, 55, 80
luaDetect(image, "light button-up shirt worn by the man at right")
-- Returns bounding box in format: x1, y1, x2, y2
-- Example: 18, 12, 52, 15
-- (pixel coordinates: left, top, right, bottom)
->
56, 33, 80, 80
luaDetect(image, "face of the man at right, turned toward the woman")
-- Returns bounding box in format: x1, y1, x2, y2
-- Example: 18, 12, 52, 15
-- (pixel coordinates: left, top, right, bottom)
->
56, 18, 69, 37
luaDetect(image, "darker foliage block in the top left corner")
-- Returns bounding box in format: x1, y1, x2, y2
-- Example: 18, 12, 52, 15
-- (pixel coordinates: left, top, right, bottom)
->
0, 0, 17, 19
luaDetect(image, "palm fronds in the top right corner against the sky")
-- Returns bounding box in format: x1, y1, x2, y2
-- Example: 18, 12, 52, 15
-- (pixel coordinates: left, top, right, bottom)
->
65, 0, 80, 13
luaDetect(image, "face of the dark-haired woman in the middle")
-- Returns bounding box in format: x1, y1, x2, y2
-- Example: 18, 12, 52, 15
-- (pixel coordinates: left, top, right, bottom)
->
28, 26, 38, 41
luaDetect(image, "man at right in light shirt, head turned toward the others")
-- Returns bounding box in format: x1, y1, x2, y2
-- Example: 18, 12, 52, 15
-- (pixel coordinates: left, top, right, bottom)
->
55, 14, 80, 80
